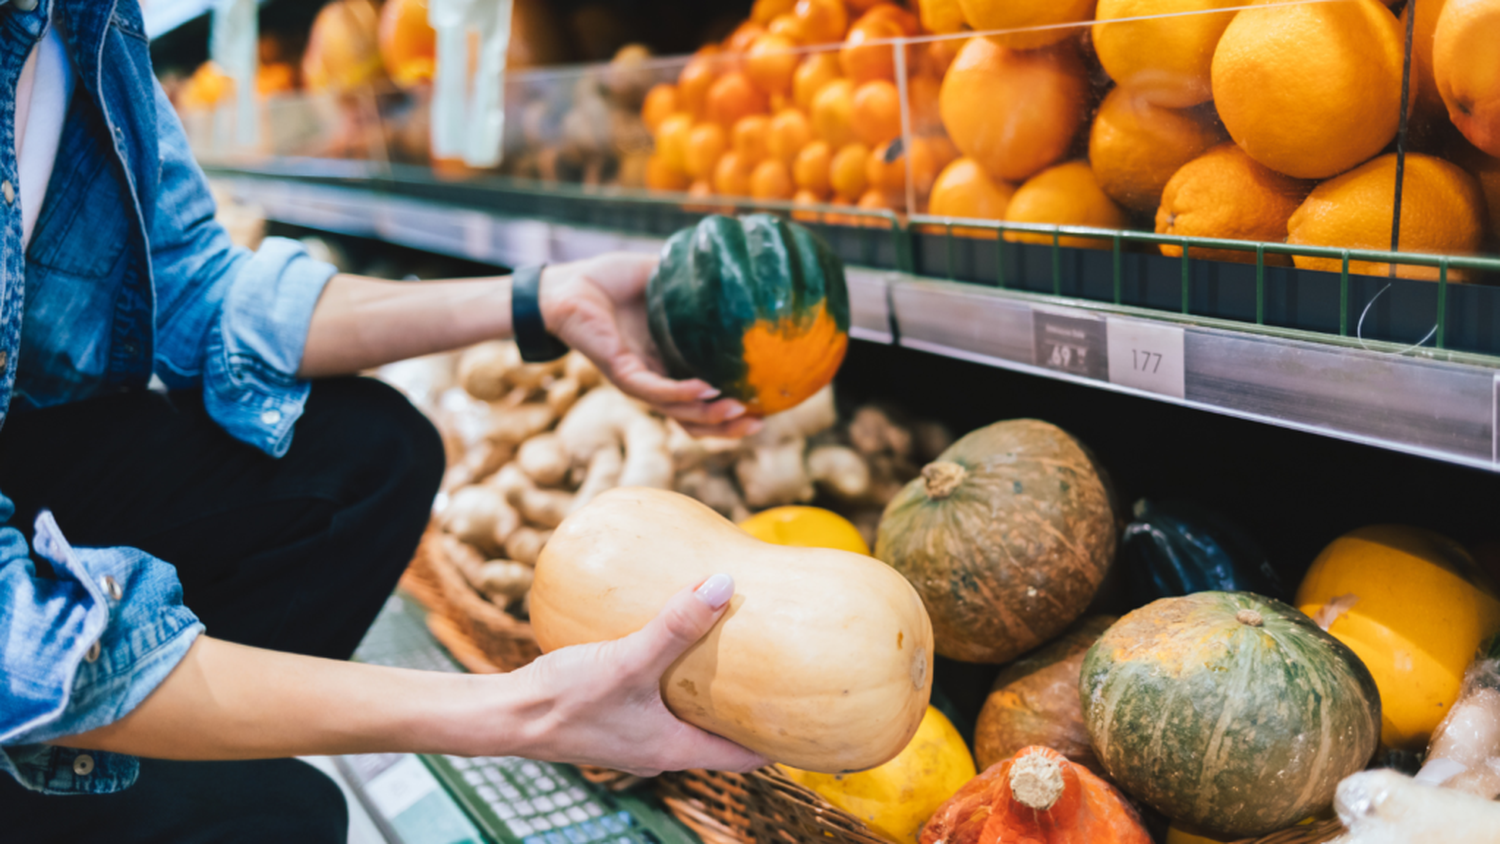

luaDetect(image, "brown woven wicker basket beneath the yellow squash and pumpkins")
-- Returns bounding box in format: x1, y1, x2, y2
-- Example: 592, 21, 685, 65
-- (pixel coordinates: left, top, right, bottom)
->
657, 768, 1344, 844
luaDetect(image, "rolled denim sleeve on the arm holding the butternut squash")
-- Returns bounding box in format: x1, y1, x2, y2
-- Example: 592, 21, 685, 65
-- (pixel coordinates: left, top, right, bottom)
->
0, 493, 203, 795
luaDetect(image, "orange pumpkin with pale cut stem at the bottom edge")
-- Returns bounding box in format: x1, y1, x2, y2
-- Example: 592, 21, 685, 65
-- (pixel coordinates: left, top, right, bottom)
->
921, 745, 1151, 844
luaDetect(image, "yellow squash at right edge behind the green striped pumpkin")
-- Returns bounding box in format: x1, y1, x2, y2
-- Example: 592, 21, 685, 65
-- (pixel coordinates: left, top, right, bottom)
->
1296, 525, 1500, 751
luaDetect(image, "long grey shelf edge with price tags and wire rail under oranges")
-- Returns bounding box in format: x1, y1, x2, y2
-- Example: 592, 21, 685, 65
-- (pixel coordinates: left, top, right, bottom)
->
209, 167, 1500, 471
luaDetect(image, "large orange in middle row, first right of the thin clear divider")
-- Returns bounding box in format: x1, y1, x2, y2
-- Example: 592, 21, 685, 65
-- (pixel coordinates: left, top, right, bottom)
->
939, 38, 1086, 181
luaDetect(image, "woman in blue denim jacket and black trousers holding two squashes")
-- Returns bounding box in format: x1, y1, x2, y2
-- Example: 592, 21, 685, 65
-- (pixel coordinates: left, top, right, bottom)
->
0, 0, 764, 844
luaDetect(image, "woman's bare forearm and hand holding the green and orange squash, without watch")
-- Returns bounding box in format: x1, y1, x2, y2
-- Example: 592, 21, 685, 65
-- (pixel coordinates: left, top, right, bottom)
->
297, 253, 761, 436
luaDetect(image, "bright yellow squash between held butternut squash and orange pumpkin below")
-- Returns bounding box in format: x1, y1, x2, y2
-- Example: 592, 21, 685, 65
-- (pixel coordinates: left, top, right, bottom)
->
783, 706, 975, 844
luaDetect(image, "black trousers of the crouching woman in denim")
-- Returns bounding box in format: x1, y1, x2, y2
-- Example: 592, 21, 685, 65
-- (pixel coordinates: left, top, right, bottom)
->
0, 378, 443, 844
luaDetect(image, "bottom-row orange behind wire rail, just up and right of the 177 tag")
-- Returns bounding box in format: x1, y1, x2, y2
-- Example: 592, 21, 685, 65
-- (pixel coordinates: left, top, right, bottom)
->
1157, 144, 1308, 267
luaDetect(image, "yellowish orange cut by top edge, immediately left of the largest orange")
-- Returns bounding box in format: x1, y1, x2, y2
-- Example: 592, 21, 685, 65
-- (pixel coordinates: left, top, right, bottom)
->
1092, 0, 1247, 108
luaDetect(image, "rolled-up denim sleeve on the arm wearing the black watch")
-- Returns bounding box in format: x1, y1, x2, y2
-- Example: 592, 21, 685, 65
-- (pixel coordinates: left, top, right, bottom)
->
149, 76, 336, 457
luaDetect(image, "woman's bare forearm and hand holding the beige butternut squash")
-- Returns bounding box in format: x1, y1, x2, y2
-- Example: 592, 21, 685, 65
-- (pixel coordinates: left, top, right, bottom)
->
54, 576, 765, 775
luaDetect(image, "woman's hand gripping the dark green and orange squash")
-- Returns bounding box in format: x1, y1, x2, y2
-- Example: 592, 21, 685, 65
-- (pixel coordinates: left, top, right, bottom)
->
540, 252, 761, 436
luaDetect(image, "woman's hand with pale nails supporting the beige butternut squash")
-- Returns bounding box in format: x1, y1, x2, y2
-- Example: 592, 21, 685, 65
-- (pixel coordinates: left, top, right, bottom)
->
509, 574, 767, 777
